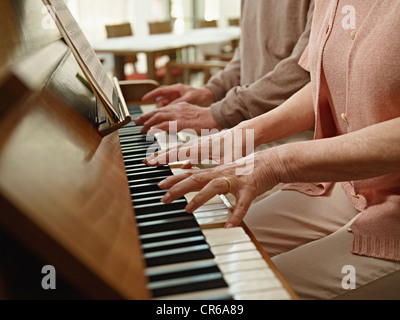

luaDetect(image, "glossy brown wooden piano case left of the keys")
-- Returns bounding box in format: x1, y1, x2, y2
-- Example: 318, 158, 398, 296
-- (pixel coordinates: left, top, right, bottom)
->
0, 0, 149, 299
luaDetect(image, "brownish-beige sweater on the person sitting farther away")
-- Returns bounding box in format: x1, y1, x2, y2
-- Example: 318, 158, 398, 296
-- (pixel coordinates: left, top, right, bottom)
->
206, 0, 314, 128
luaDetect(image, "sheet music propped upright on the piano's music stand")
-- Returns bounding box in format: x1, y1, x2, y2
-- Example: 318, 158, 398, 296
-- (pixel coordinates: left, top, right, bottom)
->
43, 0, 122, 122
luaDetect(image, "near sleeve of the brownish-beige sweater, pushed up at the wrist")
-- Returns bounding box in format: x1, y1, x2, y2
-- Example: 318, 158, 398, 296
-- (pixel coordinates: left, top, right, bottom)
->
211, 3, 314, 128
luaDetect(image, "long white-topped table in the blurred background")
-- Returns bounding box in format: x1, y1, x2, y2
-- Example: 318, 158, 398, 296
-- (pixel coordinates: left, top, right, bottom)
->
93, 27, 240, 80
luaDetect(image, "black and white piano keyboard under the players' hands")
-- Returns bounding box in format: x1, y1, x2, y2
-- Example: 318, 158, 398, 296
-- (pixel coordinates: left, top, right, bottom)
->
119, 107, 291, 300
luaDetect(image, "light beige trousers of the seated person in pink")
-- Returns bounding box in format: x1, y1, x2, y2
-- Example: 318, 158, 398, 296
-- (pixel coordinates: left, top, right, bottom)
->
245, 184, 400, 300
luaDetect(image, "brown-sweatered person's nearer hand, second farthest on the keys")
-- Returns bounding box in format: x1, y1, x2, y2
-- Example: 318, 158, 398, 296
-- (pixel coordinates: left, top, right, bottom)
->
135, 102, 220, 135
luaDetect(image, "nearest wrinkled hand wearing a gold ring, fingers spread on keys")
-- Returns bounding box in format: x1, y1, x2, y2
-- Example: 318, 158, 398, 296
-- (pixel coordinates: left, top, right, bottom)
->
159, 151, 279, 228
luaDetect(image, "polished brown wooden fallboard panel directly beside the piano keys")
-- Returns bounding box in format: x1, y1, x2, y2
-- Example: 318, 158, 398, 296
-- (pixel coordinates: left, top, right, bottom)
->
0, 86, 149, 299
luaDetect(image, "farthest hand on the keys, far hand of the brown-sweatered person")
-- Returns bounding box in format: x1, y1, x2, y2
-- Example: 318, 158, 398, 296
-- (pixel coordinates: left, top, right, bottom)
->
142, 84, 215, 108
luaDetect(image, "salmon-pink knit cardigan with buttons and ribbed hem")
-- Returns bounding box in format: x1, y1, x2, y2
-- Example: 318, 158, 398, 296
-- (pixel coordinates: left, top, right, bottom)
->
287, 0, 400, 261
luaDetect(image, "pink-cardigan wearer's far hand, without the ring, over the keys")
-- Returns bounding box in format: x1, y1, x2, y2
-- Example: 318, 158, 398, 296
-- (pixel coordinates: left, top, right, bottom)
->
144, 127, 255, 169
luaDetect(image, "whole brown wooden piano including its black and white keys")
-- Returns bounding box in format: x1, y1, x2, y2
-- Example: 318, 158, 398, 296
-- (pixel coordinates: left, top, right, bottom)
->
0, 0, 297, 300
